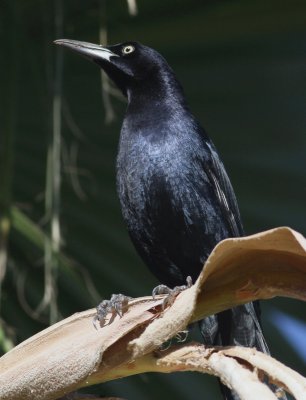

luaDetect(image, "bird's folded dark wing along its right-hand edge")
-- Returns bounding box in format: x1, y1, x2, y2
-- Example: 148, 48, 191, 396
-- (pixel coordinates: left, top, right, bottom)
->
206, 143, 244, 237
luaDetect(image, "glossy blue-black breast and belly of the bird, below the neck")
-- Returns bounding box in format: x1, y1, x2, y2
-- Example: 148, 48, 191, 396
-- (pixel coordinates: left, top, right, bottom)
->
117, 115, 230, 286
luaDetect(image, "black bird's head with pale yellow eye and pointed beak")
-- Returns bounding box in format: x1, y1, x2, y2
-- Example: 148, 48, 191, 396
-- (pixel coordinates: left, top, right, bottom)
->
55, 39, 171, 95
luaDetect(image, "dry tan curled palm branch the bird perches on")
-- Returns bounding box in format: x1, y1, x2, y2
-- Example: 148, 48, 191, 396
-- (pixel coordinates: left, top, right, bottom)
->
0, 228, 306, 400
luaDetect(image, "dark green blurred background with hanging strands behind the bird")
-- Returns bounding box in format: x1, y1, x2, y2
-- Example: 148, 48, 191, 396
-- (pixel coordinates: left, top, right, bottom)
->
0, 0, 306, 400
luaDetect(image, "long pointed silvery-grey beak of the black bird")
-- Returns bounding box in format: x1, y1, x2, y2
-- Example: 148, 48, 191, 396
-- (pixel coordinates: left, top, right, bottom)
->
54, 39, 119, 61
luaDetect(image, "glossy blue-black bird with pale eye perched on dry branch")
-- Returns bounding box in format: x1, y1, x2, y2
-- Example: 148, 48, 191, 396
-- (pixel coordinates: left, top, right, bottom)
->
55, 39, 282, 399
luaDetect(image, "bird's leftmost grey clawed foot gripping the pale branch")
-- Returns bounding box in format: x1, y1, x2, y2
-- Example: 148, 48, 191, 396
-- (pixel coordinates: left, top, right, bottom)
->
93, 293, 132, 329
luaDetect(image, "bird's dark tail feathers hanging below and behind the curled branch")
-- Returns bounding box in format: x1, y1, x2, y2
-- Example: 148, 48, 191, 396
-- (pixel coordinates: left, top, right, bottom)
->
200, 302, 287, 400
